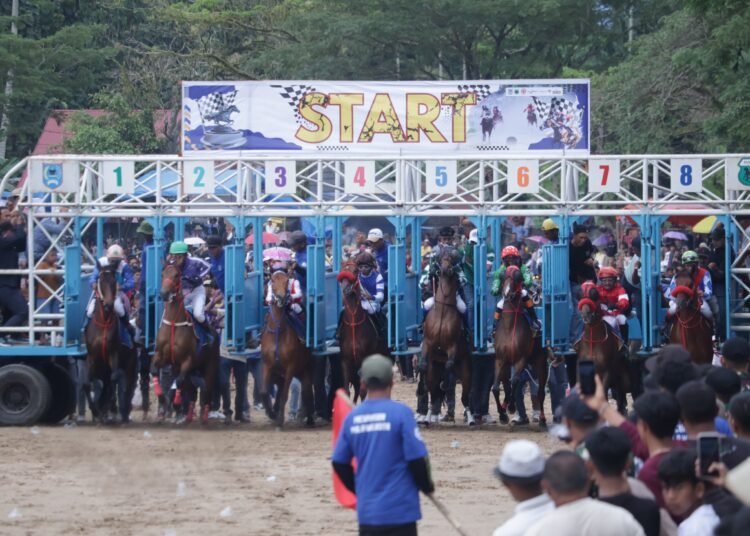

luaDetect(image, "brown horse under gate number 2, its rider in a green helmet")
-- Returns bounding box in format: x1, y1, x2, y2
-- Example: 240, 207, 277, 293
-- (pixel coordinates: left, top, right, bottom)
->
153, 263, 219, 424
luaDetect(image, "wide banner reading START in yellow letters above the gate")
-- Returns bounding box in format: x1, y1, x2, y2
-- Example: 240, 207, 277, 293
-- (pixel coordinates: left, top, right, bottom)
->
182, 79, 590, 157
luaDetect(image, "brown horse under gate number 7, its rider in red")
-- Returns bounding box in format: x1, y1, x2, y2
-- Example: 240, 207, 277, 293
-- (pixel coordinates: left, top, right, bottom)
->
573, 282, 631, 415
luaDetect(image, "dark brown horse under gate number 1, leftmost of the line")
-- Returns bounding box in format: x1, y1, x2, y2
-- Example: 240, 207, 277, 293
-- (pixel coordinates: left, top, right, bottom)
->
85, 261, 136, 423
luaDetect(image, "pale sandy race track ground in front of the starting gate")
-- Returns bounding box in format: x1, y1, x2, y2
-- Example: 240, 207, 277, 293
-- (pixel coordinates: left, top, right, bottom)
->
0, 383, 562, 536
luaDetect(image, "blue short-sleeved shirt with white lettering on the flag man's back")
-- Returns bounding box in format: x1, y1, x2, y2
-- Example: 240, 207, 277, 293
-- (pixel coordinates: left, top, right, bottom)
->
332, 400, 427, 525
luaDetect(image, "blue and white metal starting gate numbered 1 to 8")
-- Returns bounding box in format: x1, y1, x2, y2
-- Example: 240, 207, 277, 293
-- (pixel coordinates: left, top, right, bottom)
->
0, 152, 750, 356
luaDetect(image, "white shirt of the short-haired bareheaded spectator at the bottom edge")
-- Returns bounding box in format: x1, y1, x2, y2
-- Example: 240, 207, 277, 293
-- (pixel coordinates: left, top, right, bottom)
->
526, 497, 645, 536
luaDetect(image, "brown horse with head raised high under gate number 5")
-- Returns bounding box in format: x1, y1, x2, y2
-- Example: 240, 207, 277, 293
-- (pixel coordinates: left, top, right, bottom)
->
422, 249, 474, 424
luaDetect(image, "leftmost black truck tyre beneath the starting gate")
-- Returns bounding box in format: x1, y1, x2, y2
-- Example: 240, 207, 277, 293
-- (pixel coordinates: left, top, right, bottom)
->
0, 364, 52, 426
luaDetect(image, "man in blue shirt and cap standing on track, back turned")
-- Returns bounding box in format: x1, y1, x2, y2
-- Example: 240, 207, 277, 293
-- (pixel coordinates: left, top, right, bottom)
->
331, 354, 435, 536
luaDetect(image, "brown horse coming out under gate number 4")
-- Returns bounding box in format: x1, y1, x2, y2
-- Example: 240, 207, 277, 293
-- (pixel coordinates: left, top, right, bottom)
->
338, 271, 388, 404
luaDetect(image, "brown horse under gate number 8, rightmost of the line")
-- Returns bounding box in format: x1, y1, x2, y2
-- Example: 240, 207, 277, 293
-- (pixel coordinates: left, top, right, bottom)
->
669, 272, 714, 364
